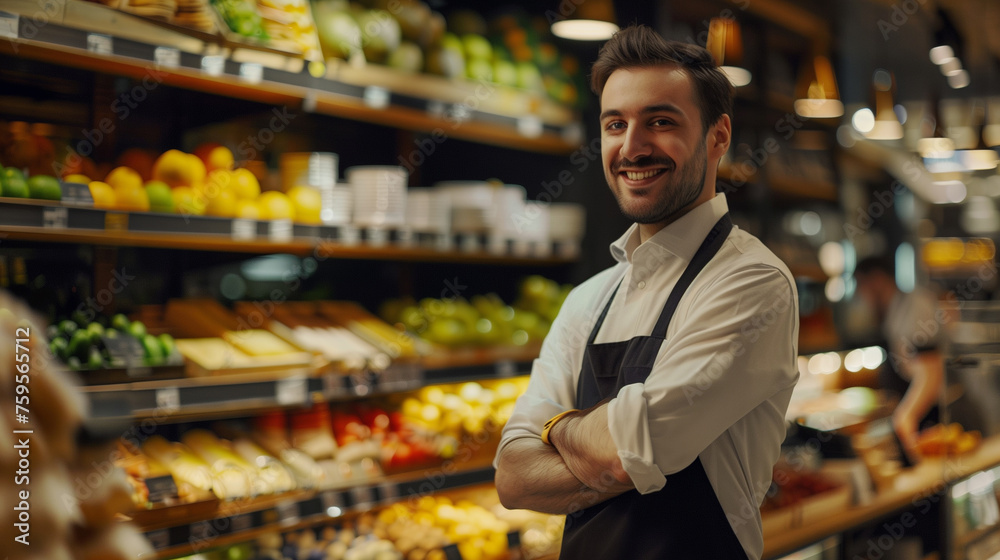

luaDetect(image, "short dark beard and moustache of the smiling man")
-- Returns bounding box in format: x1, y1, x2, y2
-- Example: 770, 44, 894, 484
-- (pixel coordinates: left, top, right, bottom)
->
612, 141, 708, 224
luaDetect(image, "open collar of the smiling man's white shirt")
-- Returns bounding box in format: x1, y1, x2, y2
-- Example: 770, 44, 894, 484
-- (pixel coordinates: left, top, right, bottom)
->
611, 193, 729, 262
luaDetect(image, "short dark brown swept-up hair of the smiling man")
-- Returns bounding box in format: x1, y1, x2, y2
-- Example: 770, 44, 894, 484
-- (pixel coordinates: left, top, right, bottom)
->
590, 25, 733, 131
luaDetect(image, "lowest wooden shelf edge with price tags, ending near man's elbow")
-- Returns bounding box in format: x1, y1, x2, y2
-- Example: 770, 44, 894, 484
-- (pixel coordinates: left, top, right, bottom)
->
139, 457, 494, 558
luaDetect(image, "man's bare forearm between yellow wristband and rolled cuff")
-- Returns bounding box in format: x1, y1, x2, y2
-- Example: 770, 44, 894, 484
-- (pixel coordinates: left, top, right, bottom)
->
549, 403, 635, 494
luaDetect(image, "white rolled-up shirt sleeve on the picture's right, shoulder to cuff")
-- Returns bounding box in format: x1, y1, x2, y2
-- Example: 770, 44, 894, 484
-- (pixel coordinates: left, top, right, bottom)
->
608, 265, 798, 493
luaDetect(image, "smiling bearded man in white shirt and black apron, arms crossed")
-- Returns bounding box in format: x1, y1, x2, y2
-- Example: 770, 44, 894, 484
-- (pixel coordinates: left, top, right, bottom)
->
495, 26, 798, 560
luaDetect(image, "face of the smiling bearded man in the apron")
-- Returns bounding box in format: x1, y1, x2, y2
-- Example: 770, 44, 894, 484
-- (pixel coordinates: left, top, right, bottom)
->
601, 65, 716, 224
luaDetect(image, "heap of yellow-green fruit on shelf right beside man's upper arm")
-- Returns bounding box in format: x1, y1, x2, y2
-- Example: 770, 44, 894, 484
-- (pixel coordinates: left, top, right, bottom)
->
380, 276, 572, 347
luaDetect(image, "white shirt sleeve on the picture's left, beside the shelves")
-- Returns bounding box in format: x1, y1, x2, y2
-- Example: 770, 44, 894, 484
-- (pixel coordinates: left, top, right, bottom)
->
494, 267, 621, 467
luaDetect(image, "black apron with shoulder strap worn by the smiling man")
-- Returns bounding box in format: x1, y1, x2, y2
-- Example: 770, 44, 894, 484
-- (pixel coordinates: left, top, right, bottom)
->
560, 214, 747, 560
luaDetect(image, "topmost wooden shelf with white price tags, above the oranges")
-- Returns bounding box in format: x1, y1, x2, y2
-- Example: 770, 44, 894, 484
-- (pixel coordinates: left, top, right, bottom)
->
0, 0, 583, 154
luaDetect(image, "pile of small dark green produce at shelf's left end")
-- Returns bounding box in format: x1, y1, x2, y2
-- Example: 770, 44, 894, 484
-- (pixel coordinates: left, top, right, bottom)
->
46, 313, 183, 370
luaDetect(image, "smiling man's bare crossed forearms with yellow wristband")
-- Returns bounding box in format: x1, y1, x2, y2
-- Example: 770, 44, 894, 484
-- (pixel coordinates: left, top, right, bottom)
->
496, 404, 633, 514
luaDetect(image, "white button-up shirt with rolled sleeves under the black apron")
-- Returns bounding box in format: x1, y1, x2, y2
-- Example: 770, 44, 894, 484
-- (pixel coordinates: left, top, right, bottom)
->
497, 194, 799, 559
